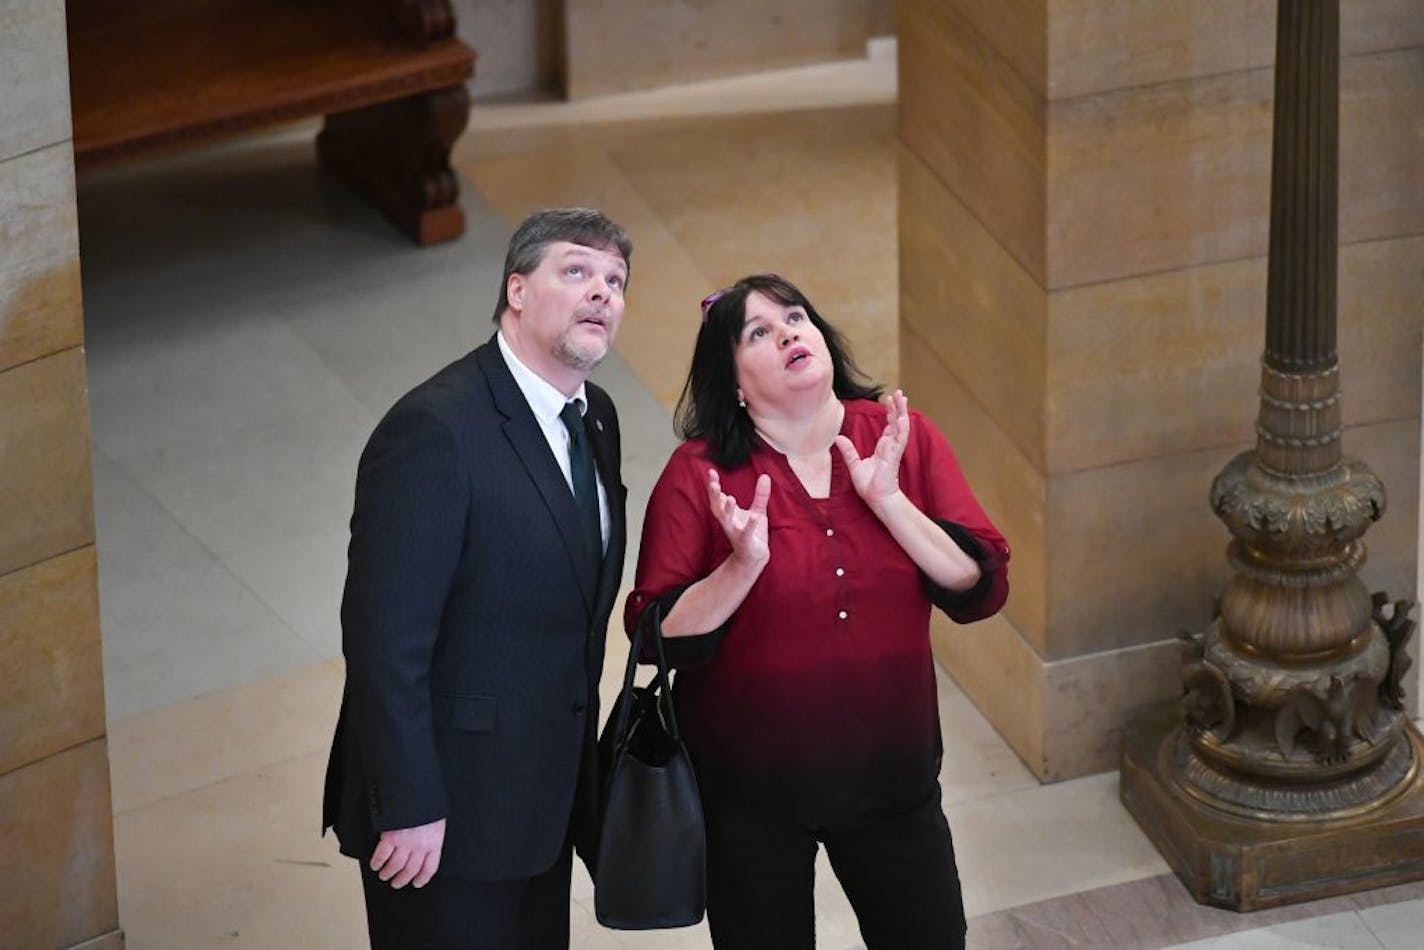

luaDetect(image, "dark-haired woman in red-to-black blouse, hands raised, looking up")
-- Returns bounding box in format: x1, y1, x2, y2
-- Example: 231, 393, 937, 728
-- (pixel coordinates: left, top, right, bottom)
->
625, 275, 1008, 950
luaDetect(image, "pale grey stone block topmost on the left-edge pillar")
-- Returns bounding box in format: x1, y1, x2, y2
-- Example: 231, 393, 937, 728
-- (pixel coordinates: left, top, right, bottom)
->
0, 0, 70, 161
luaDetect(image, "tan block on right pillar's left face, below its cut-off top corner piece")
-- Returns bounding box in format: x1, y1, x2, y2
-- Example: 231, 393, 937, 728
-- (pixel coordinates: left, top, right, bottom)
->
899, 0, 1047, 283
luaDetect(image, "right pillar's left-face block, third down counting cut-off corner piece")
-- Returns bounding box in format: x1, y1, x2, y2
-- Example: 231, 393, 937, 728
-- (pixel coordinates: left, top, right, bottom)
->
900, 150, 1048, 469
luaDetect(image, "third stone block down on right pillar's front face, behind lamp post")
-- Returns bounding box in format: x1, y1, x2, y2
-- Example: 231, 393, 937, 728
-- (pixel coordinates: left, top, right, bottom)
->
1042, 238, 1424, 473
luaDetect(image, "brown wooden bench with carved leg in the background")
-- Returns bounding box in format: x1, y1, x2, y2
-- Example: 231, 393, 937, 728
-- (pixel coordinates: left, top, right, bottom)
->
68, 0, 474, 245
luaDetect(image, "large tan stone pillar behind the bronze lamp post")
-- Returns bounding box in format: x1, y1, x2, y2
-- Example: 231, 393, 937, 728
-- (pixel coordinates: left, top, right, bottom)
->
897, 0, 1424, 781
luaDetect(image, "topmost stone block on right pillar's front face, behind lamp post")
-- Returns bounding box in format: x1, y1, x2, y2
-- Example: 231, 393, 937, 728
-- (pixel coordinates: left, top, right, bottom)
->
1047, 0, 1424, 98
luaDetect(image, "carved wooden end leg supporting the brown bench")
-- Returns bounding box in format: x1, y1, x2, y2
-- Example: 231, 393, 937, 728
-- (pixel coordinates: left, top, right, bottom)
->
316, 84, 470, 245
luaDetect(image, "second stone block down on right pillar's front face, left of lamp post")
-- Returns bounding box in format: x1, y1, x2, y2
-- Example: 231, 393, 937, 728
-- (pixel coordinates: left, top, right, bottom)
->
1047, 70, 1273, 291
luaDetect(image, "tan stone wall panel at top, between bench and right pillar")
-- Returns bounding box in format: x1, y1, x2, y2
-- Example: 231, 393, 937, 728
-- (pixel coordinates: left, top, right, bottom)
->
564, 0, 889, 98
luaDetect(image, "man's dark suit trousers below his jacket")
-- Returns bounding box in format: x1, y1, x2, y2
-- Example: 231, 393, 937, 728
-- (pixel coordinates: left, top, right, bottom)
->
360, 846, 571, 950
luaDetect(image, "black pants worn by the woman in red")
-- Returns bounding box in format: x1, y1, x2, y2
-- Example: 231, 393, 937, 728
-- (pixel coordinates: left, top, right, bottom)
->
706, 785, 964, 950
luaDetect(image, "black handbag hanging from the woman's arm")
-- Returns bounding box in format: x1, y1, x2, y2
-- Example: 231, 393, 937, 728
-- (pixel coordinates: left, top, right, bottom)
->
594, 604, 706, 930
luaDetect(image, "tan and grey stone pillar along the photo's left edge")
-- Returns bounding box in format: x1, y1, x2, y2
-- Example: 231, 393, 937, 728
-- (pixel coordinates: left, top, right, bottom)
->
0, 0, 124, 949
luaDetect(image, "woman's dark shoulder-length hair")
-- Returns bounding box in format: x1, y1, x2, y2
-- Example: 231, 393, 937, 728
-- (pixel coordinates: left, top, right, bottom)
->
674, 273, 880, 469
